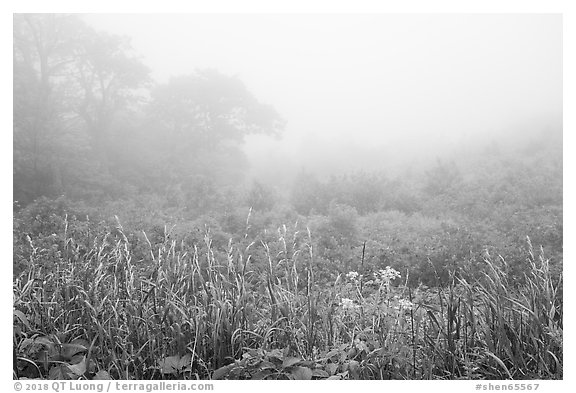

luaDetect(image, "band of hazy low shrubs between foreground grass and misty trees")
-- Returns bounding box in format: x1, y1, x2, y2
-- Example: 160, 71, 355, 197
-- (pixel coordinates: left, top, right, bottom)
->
14, 139, 563, 285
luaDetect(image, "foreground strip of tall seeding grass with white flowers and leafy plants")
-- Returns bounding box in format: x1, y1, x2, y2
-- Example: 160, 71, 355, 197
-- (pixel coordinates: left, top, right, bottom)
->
13, 216, 563, 379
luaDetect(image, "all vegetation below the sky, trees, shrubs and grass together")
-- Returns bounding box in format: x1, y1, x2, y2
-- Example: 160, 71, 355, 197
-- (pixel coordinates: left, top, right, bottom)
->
13, 14, 563, 379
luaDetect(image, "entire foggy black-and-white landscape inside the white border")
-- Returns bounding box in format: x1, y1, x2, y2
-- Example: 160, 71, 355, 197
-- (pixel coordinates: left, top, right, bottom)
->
11, 14, 565, 380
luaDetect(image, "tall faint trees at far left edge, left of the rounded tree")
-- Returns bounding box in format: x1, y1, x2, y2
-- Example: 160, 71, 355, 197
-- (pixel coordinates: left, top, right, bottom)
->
14, 14, 147, 204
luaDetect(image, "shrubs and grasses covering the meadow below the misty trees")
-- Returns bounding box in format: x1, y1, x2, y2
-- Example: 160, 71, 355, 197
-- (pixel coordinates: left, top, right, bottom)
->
14, 141, 563, 379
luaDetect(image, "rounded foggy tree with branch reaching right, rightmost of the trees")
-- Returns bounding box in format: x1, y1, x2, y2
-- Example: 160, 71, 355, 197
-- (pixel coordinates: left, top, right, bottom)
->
148, 70, 284, 205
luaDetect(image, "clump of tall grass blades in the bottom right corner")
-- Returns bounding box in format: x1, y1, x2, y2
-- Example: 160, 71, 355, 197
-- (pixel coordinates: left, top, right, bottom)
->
414, 240, 563, 379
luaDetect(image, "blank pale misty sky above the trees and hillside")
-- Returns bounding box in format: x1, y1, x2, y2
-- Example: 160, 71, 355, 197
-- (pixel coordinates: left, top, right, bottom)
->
79, 14, 562, 178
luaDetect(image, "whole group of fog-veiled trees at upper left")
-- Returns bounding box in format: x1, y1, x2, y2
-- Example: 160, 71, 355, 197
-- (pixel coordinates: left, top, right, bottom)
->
13, 14, 284, 205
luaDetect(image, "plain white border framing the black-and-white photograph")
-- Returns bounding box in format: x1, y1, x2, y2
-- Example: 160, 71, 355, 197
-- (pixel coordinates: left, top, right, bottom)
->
0, 0, 576, 392
